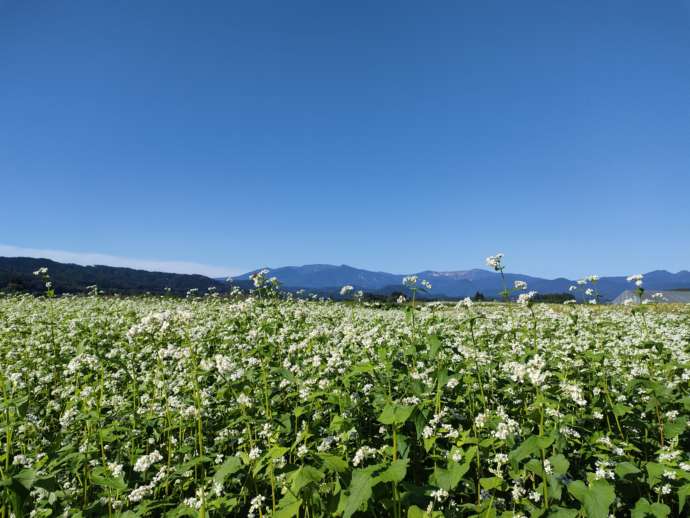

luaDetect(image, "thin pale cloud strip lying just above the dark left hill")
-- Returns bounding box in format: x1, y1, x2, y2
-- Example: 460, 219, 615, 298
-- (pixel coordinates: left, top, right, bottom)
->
0, 244, 242, 277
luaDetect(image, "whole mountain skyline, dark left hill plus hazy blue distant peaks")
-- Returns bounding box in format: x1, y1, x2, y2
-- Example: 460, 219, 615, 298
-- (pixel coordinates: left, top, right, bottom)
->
0, 257, 690, 300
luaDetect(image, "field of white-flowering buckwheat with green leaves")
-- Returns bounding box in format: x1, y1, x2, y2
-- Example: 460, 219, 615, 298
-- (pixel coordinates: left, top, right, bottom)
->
0, 272, 690, 518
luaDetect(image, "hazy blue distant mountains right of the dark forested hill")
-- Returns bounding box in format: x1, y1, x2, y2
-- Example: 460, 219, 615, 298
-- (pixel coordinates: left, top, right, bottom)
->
235, 264, 690, 300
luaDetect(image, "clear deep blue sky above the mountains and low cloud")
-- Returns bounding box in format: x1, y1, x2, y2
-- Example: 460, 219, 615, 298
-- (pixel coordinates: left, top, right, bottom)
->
0, 0, 690, 276
